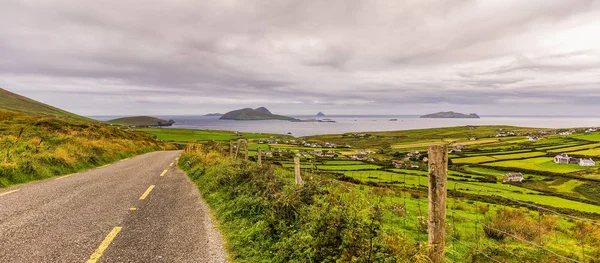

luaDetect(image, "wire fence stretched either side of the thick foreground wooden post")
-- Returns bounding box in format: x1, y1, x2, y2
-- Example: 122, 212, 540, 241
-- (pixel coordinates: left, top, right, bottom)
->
282, 158, 600, 262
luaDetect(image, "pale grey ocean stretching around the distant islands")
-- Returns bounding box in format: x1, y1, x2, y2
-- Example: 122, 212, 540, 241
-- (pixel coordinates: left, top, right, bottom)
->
89, 115, 600, 137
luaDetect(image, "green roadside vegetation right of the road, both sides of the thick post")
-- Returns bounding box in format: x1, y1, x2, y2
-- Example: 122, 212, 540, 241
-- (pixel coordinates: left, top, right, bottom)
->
179, 143, 600, 262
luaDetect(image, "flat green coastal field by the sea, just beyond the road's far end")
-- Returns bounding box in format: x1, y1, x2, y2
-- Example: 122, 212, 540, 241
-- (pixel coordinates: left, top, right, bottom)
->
136, 128, 290, 142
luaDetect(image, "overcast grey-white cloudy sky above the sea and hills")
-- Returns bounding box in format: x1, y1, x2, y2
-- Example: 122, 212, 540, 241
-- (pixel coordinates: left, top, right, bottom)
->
0, 0, 600, 115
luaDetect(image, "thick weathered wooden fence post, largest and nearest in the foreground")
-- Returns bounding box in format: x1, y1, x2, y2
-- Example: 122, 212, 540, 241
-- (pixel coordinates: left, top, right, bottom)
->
427, 145, 448, 263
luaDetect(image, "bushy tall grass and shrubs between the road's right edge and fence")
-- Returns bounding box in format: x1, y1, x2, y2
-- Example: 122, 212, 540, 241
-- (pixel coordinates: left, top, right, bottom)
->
179, 144, 428, 262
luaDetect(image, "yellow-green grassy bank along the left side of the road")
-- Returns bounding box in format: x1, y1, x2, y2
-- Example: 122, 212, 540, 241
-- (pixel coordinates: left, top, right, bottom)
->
0, 111, 171, 187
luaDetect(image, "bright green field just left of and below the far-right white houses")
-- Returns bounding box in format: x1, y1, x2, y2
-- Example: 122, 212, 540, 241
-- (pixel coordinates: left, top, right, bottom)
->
485, 157, 592, 173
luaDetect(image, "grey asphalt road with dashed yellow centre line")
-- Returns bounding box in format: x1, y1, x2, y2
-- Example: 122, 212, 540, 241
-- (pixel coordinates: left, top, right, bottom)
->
0, 151, 226, 263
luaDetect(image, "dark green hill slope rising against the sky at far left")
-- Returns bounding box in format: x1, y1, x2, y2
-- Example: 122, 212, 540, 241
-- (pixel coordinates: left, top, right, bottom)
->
0, 88, 92, 121
